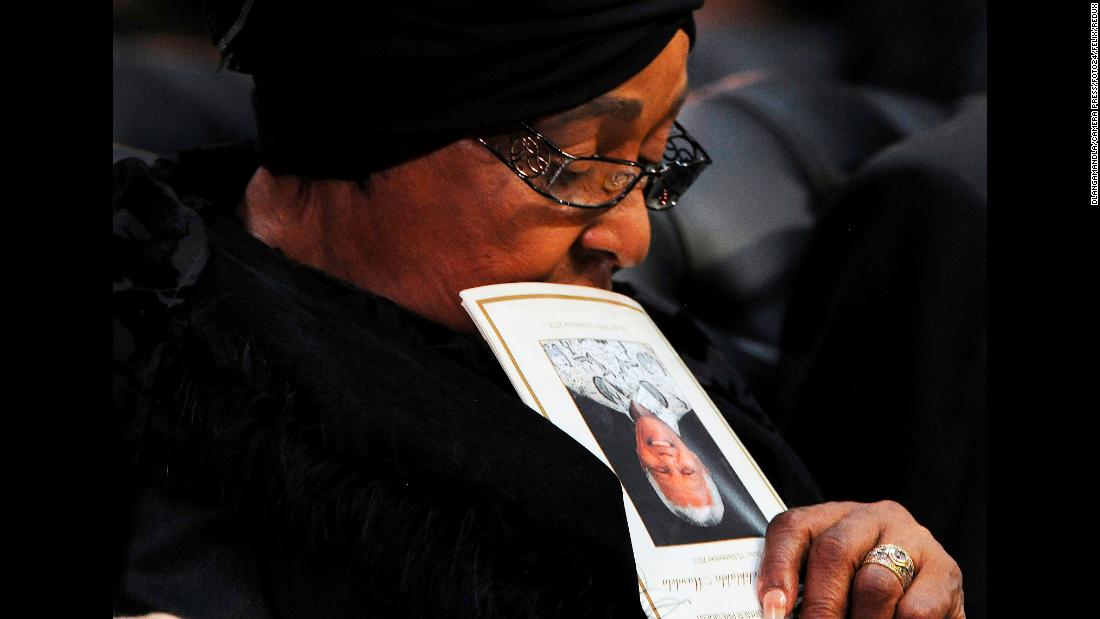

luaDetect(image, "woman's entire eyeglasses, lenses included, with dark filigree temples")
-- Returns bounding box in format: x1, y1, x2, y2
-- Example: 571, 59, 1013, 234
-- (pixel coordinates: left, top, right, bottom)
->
477, 122, 711, 211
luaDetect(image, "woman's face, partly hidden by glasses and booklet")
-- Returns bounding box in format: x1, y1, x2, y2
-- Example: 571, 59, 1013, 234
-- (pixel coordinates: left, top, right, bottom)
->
359, 31, 689, 331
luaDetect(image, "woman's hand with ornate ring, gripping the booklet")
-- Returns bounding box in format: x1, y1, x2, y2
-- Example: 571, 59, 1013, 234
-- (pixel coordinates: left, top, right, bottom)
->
758, 501, 965, 619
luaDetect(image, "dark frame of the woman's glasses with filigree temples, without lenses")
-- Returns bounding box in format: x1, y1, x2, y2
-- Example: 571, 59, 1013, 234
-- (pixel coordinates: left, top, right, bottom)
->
477, 121, 713, 211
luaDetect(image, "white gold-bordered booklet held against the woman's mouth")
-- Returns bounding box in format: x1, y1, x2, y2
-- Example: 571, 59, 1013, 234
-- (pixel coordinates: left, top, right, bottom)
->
461, 284, 787, 619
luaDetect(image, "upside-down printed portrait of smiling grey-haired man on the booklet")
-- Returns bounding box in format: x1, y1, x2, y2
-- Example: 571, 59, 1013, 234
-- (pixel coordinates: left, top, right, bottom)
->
540, 338, 768, 546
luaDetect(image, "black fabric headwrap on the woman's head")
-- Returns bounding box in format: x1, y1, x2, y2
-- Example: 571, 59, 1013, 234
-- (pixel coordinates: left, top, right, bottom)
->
207, 0, 703, 178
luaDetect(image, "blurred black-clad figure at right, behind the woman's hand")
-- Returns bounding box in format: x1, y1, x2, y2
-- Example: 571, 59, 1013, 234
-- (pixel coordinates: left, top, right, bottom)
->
772, 97, 988, 618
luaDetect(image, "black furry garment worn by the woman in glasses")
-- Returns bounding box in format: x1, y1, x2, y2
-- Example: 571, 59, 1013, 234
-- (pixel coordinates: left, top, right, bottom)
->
112, 144, 820, 618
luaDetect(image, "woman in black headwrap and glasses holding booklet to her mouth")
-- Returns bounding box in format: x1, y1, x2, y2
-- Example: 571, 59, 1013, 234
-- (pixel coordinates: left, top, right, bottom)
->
114, 0, 963, 618
